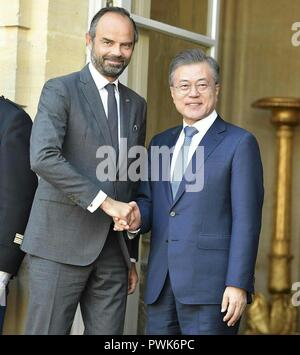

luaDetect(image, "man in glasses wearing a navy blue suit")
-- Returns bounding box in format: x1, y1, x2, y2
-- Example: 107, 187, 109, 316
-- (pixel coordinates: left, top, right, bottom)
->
115, 49, 264, 335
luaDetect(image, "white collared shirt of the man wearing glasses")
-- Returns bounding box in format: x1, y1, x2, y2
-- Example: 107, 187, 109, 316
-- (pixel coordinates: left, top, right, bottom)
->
170, 111, 218, 181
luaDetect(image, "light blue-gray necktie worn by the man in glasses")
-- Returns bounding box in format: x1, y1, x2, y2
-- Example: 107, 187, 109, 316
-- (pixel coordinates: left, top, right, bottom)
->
171, 126, 198, 199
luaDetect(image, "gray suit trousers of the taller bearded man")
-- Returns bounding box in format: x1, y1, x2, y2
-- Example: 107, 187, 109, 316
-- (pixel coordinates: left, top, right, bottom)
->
25, 233, 128, 335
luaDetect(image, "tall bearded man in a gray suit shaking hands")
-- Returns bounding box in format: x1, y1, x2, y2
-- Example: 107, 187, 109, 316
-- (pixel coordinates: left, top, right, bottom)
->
22, 7, 146, 334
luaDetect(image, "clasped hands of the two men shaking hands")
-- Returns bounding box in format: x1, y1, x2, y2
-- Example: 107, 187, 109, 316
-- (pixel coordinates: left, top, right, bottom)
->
101, 197, 141, 232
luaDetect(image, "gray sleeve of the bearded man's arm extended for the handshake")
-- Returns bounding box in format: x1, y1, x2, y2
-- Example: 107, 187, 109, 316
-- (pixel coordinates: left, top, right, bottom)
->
30, 79, 101, 209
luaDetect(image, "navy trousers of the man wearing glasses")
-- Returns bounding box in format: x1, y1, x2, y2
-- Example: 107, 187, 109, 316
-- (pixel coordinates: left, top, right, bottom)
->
147, 275, 239, 335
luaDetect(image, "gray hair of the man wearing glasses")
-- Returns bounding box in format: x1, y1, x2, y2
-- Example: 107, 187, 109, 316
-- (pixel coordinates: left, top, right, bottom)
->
169, 48, 220, 86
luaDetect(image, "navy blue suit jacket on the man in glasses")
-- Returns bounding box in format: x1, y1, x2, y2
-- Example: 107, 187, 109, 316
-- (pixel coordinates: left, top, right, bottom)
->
137, 117, 264, 304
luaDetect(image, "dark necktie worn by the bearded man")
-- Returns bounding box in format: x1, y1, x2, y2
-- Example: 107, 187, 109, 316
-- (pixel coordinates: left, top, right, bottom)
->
105, 84, 119, 159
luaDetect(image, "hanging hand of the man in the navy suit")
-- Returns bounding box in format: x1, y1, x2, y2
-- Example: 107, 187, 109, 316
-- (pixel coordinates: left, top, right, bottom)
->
221, 286, 247, 327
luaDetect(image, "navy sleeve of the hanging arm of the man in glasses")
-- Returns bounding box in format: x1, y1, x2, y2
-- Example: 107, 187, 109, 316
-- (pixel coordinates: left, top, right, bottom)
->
226, 134, 264, 293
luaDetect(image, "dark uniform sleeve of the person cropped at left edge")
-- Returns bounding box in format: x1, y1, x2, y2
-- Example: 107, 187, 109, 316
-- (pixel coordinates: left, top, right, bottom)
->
0, 110, 37, 275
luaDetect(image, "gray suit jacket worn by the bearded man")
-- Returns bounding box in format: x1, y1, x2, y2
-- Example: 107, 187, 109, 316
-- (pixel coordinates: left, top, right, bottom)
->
22, 66, 146, 266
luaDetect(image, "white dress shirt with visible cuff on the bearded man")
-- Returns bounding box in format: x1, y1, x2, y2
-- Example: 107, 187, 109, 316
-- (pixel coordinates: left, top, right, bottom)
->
88, 63, 121, 213
